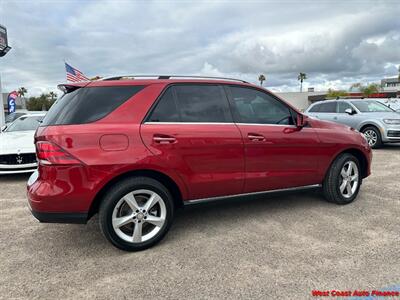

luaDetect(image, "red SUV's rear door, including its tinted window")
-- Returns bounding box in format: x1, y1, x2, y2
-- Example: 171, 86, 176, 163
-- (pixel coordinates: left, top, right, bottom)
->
141, 84, 244, 199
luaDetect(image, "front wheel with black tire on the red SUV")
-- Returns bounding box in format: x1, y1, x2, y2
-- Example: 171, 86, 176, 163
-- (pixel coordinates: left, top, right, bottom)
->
322, 153, 362, 204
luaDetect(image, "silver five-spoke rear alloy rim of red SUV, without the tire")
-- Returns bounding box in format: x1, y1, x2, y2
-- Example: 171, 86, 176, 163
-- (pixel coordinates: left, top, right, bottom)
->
112, 189, 167, 243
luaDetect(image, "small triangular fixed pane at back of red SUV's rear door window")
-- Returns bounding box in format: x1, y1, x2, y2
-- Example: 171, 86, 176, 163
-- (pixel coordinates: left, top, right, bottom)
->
149, 88, 180, 122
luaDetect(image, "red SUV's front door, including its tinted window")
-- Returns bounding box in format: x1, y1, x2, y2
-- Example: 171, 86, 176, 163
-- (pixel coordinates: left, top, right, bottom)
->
226, 85, 322, 193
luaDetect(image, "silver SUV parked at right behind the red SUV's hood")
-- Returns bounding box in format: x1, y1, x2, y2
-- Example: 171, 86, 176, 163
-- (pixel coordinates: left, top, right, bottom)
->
306, 99, 400, 148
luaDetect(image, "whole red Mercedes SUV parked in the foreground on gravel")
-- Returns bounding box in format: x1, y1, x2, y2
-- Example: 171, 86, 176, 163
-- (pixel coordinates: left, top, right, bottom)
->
28, 76, 372, 251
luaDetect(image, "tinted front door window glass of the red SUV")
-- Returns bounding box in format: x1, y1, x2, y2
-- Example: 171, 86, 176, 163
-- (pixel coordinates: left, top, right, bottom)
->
230, 86, 293, 124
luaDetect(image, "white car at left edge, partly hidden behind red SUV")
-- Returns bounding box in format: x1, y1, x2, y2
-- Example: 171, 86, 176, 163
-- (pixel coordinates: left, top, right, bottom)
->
0, 114, 44, 174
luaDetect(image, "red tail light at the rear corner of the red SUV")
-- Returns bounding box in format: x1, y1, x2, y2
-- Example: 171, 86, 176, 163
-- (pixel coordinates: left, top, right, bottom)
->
36, 142, 82, 165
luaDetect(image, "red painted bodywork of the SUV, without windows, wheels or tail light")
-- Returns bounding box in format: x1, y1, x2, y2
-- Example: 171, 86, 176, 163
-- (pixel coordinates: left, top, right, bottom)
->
28, 79, 372, 220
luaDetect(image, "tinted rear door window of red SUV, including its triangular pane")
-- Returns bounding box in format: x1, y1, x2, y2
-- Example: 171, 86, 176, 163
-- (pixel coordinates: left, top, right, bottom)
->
149, 84, 232, 123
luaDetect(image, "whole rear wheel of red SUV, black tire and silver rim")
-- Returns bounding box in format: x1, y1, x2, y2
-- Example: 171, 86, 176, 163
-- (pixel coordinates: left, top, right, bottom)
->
99, 177, 174, 251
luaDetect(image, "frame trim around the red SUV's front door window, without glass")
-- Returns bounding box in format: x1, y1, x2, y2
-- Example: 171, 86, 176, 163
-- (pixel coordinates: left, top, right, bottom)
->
224, 84, 296, 127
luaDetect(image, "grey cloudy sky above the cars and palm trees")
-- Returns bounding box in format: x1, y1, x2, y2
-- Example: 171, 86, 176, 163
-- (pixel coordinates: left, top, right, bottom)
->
0, 0, 400, 95
